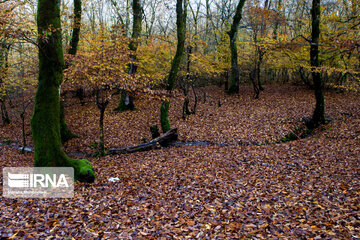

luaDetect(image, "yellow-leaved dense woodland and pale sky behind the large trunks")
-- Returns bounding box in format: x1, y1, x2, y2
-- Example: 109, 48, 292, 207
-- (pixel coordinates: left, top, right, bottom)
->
1, 0, 360, 101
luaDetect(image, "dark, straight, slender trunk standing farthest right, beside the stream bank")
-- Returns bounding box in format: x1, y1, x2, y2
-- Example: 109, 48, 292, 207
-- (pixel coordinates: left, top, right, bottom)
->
310, 0, 325, 127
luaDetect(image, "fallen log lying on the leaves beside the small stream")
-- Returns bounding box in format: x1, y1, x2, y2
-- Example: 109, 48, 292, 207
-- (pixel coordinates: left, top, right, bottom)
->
108, 128, 178, 154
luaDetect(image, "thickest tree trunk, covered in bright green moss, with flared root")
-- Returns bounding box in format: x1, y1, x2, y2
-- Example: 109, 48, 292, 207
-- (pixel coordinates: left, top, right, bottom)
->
31, 0, 95, 182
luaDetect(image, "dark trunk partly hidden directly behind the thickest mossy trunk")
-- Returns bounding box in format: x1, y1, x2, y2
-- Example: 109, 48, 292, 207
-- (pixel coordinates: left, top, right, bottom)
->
60, 0, 81, 144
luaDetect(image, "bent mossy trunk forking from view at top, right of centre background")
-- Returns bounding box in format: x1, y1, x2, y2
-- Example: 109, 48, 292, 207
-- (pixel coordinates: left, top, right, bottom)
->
228, 0, 245, 94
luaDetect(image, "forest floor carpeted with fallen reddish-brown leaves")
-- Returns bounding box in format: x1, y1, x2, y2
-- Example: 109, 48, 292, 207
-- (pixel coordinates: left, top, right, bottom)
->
0, 86, 360, 239
